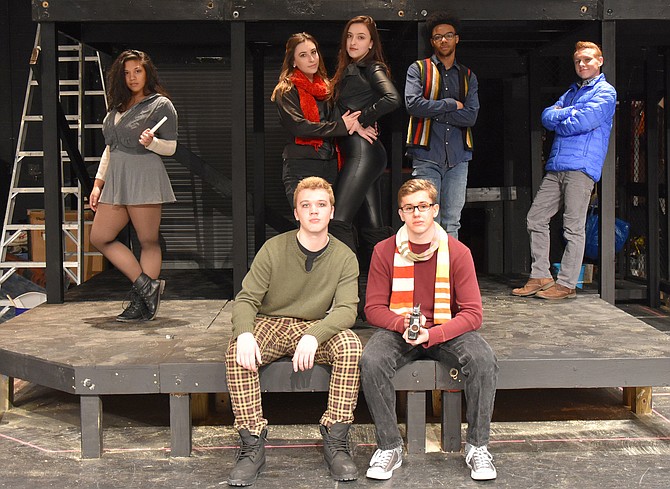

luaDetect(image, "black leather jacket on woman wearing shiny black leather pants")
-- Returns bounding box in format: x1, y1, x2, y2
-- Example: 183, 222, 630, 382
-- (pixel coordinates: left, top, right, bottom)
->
337, 62, 401, 127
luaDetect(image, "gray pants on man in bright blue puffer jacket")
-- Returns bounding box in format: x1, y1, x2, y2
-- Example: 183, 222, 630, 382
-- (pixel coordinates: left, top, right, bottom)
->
526, 171, 595, 289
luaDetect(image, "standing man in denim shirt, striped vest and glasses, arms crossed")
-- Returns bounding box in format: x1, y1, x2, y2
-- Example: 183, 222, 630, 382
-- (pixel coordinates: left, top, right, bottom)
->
405, 12, 479, 238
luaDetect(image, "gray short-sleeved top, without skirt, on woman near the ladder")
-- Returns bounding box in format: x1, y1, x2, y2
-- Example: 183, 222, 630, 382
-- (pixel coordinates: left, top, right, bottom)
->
102, 93, 177, 155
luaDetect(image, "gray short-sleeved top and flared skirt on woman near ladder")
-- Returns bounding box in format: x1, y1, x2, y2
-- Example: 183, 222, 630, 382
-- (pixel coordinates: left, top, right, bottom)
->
100, 94, 177, 205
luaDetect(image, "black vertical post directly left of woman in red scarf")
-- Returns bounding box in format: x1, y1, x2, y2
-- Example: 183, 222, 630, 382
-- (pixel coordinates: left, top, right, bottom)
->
230, 22, 249, 295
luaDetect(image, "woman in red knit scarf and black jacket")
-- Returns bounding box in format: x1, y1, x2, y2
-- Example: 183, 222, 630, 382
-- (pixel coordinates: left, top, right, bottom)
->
271, 32, 377, 209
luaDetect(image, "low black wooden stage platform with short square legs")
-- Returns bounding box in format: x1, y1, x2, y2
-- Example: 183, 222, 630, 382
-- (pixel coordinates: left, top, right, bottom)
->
0, 271, 670, 458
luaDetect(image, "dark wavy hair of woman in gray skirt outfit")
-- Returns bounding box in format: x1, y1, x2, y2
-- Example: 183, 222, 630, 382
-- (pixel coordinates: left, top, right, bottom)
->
107, 49, 170, 112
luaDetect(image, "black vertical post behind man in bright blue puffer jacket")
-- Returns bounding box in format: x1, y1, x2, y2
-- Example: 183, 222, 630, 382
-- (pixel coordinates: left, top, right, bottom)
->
598, 21, 617, 304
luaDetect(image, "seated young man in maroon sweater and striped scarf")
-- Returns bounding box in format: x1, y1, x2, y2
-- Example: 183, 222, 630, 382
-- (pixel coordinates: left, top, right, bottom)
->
361, 179, 498, 480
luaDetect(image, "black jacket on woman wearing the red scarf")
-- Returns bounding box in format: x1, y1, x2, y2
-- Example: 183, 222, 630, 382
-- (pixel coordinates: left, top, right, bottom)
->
275, 87, 349, 160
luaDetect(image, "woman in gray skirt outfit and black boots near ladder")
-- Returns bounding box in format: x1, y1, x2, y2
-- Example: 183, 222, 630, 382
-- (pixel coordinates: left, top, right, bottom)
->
89, 50, 177, 321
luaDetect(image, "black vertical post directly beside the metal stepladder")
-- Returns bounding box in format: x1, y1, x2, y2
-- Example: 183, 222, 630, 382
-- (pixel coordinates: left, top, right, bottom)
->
40, 22, 65, 304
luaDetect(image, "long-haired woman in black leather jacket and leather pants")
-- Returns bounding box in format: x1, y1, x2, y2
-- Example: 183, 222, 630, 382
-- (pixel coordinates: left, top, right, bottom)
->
330, 15, 401, 252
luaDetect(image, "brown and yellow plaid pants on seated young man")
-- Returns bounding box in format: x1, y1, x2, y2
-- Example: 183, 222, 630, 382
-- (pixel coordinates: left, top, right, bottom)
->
226, 316, 363, 435
